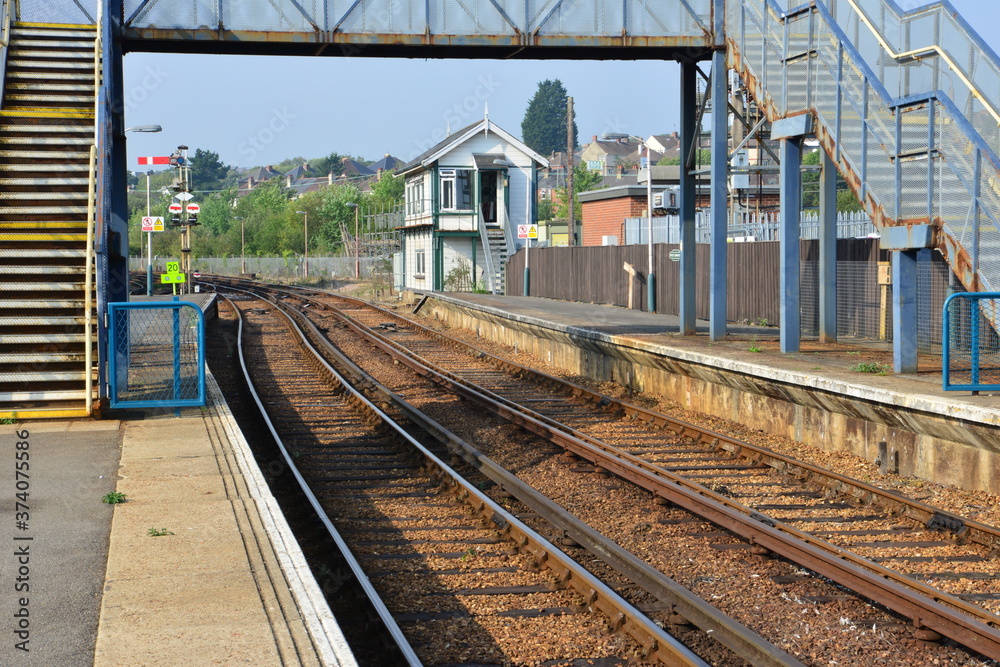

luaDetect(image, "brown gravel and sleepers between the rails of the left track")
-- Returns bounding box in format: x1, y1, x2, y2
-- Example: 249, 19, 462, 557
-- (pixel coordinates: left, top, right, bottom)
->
223, 298, 656, 665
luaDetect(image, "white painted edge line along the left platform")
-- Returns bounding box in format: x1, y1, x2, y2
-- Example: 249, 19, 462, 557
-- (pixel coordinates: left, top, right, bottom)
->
205, 369, 358, 667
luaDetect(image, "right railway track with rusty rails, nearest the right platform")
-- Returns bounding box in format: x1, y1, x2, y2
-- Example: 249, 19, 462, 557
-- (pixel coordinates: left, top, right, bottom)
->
205, 276, 1000, 657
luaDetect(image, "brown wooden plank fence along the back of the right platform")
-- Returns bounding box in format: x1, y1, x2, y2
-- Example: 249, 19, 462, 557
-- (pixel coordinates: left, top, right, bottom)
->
507, 239, 964, 354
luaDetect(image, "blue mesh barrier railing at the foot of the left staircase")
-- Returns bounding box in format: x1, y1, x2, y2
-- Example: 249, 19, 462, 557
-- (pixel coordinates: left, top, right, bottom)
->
108, 301, 205, 408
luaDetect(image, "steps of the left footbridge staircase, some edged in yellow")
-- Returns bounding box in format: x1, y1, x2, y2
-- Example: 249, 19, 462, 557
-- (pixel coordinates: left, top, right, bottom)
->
0, 23, 97, 420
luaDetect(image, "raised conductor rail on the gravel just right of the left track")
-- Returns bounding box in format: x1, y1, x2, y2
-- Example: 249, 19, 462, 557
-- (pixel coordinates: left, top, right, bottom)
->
260, 284, 803, 666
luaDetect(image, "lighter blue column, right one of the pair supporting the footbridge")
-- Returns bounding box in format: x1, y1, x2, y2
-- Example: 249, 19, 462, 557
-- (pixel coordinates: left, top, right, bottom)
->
708, 49, 729, 340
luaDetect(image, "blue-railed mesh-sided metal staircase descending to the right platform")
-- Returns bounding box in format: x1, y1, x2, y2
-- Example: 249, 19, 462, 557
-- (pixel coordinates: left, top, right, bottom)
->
726, 0, 1000, 291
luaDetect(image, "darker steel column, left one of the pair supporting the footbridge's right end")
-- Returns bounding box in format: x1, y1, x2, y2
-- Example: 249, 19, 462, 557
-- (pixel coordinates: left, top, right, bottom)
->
679, 63, 698, 336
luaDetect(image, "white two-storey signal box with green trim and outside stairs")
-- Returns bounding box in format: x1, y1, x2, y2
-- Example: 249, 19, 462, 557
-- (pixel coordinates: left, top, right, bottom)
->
397, 115, 549, 293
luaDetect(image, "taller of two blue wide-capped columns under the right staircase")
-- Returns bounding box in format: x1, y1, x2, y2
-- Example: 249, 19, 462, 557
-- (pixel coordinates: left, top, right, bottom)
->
779, 137, 802, 352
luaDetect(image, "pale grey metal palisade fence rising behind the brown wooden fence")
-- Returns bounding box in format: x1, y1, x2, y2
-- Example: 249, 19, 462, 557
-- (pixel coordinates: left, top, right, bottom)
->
619, 211, 878, 245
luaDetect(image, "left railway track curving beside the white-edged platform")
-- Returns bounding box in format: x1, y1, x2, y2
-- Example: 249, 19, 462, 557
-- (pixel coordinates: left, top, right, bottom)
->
221, 294, 772, 665
